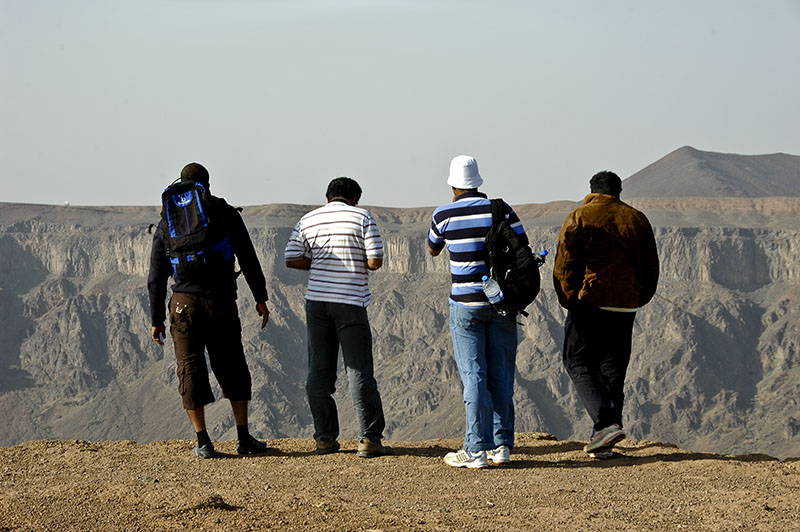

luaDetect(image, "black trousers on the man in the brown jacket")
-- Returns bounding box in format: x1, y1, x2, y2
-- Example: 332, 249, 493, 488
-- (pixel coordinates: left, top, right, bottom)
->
563, 305, 636, 431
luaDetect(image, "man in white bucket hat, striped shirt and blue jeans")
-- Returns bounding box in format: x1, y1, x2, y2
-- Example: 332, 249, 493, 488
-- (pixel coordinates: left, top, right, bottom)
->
428, 155, 525, 469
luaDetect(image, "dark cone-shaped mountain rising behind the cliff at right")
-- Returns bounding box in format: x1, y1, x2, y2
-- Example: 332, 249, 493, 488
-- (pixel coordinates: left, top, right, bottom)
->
622, 146, 800, 198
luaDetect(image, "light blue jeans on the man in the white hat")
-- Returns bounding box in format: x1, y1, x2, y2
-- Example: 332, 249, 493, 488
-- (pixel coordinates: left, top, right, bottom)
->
450, 301, 517, 452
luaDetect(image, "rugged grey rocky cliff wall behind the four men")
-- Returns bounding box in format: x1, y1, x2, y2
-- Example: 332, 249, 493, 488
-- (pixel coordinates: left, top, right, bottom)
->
0, 198, 800, 456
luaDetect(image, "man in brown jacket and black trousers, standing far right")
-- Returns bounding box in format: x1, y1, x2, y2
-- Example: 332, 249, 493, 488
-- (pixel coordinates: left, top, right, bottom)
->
553, 171, 659, 458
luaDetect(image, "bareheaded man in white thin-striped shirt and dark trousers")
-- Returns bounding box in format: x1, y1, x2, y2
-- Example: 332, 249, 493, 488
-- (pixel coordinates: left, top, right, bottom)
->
284, 177, 391, 458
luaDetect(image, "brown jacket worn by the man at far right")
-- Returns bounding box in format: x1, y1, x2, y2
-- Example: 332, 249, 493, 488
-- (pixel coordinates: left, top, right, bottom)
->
553, 194, 658, 308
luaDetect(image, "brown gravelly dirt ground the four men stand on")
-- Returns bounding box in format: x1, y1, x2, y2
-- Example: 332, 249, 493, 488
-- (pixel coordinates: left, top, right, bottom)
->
0, 434, 800, 532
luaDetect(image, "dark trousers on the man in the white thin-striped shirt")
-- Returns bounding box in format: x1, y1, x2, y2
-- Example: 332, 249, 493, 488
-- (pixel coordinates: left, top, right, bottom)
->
306, 300, 386, 442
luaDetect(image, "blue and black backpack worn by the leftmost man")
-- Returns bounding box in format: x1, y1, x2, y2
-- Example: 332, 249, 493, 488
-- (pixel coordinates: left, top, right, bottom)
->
161, 181, 234, 281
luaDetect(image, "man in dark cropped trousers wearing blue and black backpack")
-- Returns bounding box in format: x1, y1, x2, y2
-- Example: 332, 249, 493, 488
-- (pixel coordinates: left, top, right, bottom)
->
147, 163, 269, 458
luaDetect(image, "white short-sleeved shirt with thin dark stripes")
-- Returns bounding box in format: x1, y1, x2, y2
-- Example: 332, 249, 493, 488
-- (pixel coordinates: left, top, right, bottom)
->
284, 200, 383, 307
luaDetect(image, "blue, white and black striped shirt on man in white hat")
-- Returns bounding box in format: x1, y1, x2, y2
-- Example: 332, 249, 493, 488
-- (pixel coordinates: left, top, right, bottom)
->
428, 191, 525, 307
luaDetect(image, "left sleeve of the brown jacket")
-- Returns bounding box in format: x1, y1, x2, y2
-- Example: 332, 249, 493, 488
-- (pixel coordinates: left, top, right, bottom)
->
553, 211, 585, 308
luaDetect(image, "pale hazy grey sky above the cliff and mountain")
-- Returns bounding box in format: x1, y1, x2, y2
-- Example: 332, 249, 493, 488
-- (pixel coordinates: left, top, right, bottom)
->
0, 0, 800, 207
